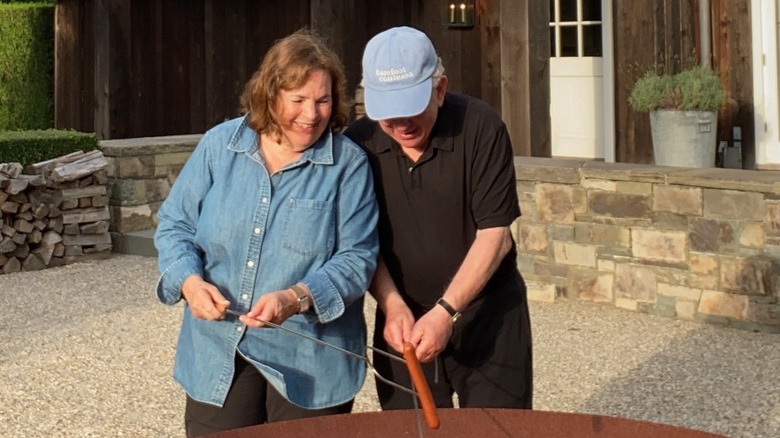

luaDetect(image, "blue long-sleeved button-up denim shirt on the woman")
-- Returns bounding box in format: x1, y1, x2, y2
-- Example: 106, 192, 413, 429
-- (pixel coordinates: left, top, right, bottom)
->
155, 117, 379, 409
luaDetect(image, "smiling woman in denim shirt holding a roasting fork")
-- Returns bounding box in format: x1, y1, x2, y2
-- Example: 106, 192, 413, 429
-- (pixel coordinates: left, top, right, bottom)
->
155, 30, 378, 436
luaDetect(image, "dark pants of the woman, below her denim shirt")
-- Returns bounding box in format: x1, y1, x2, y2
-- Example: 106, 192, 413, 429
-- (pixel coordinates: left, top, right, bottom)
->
184, 354, 353, 437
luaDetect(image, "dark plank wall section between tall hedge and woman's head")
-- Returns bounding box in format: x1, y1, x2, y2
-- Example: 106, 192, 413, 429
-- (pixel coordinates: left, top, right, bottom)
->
55, 0, 310, 139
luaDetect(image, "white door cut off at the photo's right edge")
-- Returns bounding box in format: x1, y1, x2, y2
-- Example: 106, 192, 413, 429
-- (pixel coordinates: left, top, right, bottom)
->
751, 0, 780, 170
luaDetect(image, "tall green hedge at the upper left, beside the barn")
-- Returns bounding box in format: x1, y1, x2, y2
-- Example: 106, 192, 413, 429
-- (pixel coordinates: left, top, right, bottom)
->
0, 3, 54, 131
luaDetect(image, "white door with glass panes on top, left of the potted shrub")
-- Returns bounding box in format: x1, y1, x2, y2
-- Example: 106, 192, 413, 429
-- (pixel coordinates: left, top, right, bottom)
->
550, 0, 614, 161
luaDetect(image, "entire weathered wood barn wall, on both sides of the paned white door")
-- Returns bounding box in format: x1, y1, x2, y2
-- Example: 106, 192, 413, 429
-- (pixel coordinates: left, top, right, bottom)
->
55, 0, 755, 164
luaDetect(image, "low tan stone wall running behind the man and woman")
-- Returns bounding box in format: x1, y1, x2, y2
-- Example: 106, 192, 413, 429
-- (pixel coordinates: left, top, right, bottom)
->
101, 135, 780, 333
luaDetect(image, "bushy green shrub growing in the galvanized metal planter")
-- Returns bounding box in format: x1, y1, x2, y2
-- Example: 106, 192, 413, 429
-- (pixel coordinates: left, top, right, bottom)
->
628, 66, 726, 112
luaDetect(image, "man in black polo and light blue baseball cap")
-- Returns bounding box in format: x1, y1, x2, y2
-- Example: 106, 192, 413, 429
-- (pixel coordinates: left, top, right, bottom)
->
346, 27, 532, 409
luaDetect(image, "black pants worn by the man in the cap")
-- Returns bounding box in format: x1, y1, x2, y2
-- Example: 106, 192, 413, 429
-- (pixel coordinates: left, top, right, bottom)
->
374, 275, 533, 410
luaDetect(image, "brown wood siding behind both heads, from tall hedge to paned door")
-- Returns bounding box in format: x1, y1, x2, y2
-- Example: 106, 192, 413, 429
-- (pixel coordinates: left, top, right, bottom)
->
55, 0, 550, 151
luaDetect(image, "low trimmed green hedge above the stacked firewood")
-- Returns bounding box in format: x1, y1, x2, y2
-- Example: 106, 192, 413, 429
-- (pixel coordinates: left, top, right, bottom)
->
0, 129, 98, 167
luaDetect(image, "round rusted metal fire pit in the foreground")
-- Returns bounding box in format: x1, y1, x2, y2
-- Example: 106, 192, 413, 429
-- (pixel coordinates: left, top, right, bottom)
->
206, 409, 723, 438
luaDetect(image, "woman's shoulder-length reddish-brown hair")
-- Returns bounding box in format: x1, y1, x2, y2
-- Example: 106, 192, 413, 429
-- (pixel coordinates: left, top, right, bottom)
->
241, 29, 349, 141
